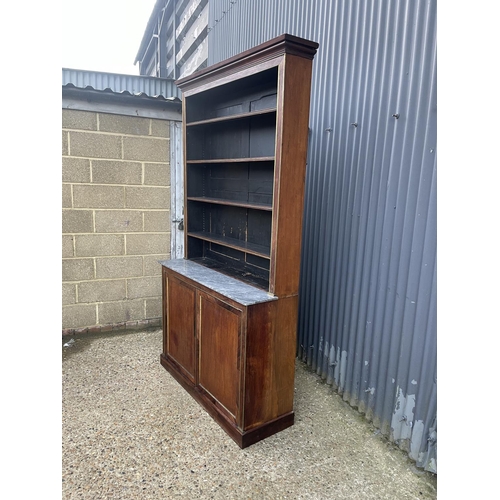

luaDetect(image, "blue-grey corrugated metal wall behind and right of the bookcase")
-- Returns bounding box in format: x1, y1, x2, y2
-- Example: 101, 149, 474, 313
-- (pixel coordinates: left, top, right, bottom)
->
208, 0, 437, 472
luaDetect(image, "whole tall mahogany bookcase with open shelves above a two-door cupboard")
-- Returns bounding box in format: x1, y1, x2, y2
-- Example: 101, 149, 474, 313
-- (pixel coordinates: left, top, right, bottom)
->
160, 34, 318, 448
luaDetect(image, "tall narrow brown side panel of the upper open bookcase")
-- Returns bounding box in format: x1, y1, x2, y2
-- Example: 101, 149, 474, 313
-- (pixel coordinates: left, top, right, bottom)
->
270, 54, 312, 297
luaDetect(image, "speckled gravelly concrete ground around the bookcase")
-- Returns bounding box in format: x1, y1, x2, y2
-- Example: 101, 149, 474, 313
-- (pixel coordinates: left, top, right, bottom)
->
62, 330, 437, 500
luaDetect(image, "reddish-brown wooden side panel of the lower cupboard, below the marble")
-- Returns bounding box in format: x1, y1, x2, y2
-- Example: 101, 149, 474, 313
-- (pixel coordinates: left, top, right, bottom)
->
245, 296, 298, 430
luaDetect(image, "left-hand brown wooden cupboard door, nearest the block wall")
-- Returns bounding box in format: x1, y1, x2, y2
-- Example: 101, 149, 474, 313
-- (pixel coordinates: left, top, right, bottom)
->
166, 276, 196, 383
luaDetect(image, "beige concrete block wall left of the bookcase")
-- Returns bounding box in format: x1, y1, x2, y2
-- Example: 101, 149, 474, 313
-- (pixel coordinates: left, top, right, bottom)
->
62, 109, 170, 334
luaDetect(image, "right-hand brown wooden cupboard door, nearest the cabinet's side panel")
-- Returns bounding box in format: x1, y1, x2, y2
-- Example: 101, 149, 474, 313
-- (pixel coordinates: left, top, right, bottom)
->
198, 293, 241, 419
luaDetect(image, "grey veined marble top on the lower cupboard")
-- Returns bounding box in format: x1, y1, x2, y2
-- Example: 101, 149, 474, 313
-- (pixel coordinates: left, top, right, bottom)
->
160, 259, 277, 306
